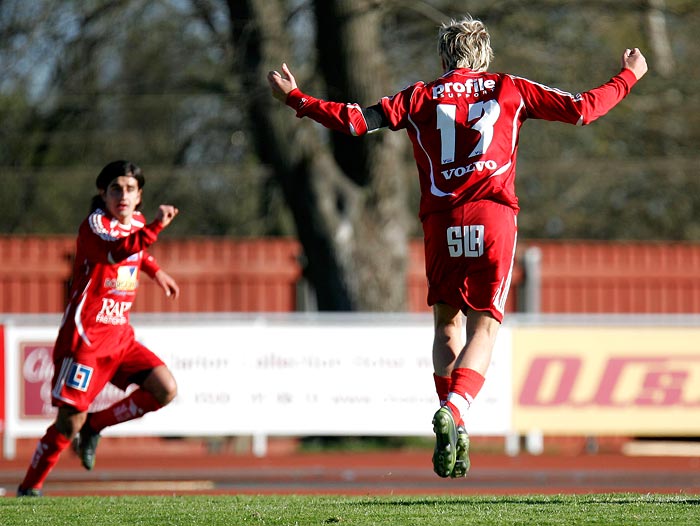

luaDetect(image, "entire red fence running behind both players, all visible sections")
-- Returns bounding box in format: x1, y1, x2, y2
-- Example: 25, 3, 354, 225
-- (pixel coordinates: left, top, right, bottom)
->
0, 236, 700, 313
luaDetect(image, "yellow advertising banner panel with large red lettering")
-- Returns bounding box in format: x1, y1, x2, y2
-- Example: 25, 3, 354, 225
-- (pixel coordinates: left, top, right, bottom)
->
512, 326, 700, 436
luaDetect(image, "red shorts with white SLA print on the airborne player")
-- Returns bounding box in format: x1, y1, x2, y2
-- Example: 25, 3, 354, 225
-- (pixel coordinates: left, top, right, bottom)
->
423, 200, 518, 322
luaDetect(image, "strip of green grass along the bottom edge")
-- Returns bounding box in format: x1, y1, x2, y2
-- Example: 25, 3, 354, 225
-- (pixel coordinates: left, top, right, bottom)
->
0, 494, 700, 526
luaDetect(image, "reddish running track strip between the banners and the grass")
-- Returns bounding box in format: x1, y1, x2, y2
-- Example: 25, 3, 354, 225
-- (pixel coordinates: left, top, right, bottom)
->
0, 438, 700, 496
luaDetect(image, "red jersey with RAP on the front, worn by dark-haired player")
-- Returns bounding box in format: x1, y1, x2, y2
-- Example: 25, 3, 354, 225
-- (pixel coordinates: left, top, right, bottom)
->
56, 209, 163, 352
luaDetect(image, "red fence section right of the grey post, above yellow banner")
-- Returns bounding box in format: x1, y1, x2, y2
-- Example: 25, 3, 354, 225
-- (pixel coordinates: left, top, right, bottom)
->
530, 242, 700, 313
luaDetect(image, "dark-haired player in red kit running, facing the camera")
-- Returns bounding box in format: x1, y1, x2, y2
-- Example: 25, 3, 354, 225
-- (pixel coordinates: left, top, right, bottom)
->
17, 161, 180, 497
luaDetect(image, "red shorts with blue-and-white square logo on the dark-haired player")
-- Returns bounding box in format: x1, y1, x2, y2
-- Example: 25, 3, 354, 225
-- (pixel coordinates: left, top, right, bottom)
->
51, 327, 164, 411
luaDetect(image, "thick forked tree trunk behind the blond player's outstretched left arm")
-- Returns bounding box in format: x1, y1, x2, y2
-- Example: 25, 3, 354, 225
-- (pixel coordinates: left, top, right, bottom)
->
229, 0, 413, 311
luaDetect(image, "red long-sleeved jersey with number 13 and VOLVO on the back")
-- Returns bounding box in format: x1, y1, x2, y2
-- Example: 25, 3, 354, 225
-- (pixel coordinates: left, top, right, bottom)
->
287, 69, 637, 219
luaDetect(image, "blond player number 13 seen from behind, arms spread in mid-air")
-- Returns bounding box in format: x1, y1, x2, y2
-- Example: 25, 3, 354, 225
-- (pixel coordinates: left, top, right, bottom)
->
267, 16, 647, 477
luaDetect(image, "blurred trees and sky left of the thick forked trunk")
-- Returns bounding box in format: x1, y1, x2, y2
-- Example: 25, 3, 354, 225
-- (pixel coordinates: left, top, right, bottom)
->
0, 0, 293, 236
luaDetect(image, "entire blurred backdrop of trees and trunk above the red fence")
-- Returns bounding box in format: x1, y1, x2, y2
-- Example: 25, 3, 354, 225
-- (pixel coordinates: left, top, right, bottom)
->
0, 0, 700, 310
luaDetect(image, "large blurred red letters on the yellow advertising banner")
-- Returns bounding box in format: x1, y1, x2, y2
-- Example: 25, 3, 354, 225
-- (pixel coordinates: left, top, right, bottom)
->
518, 356, 700, 408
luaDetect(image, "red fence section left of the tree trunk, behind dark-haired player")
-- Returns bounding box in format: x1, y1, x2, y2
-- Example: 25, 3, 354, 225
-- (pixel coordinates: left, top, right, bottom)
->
0, 236, 301, 313
